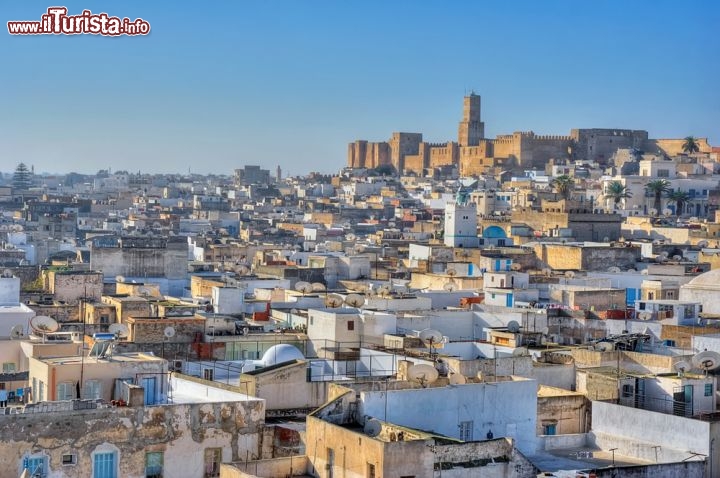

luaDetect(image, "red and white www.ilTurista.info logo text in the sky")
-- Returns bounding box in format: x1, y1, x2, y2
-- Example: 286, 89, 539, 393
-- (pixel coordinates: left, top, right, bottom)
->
8, 7, 150, 36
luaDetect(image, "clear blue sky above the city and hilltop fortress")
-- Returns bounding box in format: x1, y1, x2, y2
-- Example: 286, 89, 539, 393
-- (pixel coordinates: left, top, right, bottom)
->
0, 0, 720, 174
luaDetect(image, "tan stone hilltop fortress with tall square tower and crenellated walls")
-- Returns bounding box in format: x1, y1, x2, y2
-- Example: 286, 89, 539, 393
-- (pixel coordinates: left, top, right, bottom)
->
347, 93, 712, 176
